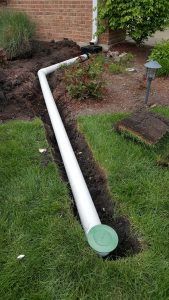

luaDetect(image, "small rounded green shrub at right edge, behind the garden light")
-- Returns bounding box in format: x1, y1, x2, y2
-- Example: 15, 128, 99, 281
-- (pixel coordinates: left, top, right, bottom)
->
149, 40, 169, 76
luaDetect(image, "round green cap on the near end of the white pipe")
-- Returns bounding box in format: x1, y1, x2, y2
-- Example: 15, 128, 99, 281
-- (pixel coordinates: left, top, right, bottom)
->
87, 224, 118, 254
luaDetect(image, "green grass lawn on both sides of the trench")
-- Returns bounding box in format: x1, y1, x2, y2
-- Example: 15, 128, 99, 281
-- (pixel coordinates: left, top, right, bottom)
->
0, 109, 169, 300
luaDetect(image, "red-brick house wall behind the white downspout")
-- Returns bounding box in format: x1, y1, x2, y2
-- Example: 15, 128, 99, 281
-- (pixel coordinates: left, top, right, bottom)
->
0, 0, 125, 44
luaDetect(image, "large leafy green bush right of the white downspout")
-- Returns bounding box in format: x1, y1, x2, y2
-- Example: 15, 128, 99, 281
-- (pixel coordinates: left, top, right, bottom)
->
99, 0, 169, 44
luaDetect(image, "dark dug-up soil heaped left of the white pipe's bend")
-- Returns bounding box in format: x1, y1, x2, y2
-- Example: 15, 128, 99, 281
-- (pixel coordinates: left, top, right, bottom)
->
0, 40, 81, 121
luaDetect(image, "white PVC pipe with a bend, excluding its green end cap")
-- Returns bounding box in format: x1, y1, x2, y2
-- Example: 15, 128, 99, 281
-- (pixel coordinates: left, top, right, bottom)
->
38, 54, 101, 234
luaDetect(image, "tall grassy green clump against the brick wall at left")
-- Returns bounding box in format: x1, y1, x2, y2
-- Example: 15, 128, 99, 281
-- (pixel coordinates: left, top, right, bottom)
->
0, 10, 35, 59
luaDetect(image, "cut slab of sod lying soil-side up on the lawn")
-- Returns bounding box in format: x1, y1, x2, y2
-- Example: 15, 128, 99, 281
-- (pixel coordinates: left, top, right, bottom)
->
115, 110, 169, 145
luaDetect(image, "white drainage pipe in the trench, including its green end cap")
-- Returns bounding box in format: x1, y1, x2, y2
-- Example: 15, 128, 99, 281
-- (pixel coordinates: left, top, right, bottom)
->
38, 54, 118, 256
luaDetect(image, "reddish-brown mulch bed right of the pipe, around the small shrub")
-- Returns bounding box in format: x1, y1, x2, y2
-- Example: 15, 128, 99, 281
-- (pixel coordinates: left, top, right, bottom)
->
51, 43, 169, 115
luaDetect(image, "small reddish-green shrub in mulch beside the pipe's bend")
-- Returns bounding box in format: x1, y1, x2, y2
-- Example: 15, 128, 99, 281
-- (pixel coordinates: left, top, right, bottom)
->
65, 56, 104, 100
